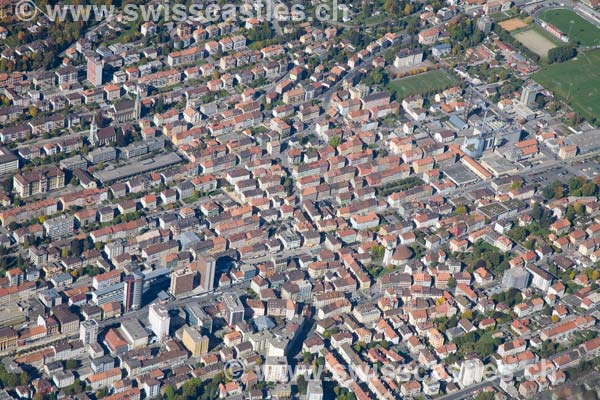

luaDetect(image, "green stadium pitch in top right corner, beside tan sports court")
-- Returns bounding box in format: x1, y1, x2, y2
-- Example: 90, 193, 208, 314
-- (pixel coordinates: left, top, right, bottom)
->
539, 9, 600, 46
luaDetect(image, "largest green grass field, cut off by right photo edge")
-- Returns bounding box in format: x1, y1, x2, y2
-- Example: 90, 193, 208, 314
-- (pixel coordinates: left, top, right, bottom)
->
533, 50, 600, 121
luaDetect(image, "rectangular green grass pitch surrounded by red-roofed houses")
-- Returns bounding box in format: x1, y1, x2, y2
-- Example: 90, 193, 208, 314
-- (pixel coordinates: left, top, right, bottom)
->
388, 70, 458, 101
